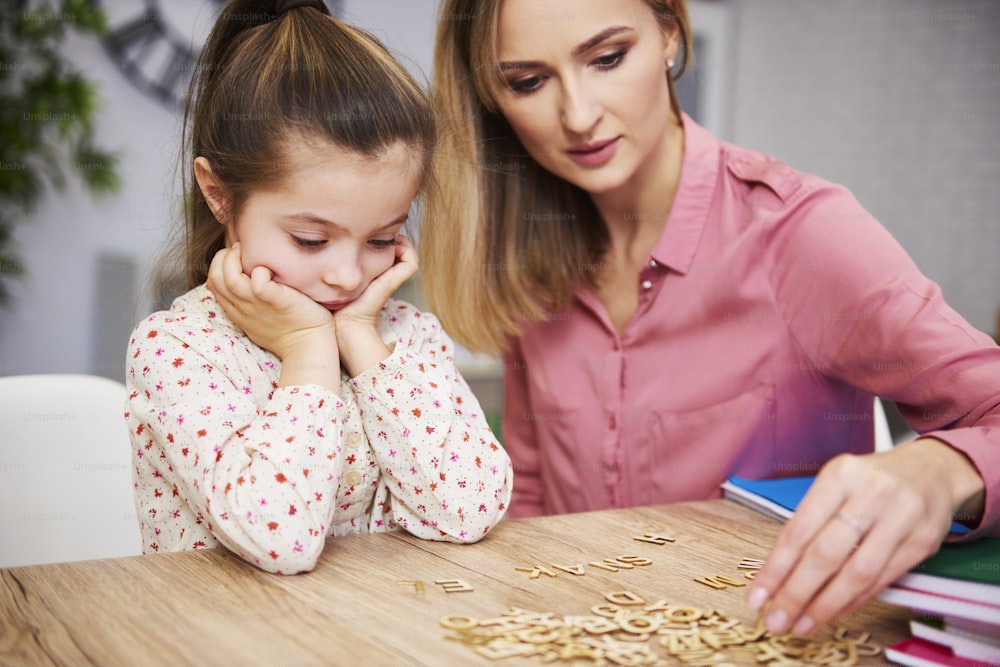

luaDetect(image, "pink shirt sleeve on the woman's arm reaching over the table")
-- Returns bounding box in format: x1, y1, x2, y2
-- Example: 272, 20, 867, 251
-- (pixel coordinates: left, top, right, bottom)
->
772, 177, 1000, 537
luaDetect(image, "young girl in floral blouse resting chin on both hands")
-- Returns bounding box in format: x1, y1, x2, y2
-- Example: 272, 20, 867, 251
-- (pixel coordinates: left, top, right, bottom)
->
126, 0, 511, 574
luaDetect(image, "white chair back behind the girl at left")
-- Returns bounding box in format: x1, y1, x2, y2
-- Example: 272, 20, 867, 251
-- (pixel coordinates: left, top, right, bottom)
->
0, 374, 141, 567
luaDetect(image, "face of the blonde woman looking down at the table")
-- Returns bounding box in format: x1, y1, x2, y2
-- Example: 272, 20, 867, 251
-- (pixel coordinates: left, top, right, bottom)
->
497, 0, 678, 194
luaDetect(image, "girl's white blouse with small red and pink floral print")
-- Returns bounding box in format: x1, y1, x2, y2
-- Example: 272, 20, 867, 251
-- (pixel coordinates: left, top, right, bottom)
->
125, 285, 512, 574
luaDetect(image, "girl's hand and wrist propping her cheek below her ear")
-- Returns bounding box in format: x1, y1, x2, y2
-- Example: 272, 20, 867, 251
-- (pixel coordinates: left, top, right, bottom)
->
207, 244, 340, 392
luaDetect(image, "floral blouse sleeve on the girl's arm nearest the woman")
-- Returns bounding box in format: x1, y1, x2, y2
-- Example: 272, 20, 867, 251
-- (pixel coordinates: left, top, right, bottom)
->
351, 302, 512, 542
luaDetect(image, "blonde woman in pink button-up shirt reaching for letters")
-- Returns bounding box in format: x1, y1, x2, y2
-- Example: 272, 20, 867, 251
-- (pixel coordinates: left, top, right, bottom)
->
421, 0, 1000, 633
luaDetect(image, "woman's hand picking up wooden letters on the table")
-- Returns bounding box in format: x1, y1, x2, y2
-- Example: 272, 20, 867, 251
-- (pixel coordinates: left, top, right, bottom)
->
747, 438, 984, 634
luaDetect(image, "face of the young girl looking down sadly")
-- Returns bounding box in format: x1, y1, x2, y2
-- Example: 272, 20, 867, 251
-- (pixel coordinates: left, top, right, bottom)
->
199, 140, 422, 310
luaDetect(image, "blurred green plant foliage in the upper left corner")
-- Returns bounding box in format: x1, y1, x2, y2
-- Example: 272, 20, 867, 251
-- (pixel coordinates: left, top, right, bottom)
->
0, 0, 120, 306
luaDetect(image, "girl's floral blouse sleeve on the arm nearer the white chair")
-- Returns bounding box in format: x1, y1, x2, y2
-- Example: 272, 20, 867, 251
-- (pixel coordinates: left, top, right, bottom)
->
127, 313, 346, 574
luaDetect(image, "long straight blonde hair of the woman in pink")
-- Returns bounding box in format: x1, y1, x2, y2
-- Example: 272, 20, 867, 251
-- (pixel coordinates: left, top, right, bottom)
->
420, 0, 691, 353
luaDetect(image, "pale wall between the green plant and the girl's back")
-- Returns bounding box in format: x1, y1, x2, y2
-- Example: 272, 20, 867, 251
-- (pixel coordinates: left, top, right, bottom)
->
0, 22, 179, 375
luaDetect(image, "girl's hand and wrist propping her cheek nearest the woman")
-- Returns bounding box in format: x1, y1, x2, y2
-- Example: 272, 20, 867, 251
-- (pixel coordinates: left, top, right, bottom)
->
333, 235, 417, 377
